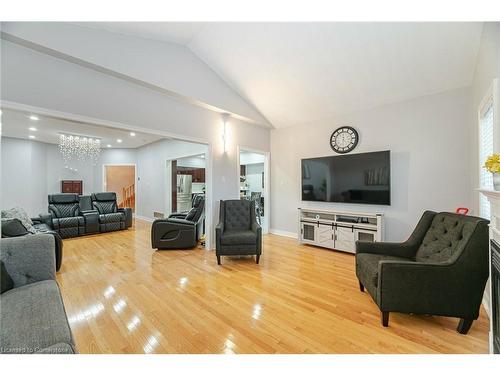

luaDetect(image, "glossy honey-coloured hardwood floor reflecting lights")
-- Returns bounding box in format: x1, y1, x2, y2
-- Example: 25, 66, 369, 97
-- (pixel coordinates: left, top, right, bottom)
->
57, 221, 488, 353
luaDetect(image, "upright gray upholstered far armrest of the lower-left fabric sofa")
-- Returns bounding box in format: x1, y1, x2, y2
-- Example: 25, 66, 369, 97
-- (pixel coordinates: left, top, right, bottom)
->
0, 234, 56, 288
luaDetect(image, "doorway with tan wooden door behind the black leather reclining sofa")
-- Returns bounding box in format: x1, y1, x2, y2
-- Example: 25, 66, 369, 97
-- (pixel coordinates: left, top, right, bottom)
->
103, 164, 136, 213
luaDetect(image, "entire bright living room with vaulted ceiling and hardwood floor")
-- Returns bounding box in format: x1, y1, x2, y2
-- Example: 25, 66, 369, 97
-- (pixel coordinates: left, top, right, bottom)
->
0, 1, 500, 374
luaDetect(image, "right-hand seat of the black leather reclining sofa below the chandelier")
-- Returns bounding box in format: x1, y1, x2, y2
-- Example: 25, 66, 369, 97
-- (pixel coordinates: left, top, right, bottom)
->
92, 192, 131, 232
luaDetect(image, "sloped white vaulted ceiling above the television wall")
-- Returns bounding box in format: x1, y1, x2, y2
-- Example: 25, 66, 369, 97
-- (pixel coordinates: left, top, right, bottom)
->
58, 22, 482, 127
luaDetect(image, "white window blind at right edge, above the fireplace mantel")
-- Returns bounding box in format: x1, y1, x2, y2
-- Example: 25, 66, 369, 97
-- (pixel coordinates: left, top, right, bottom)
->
479, 100, 494, 219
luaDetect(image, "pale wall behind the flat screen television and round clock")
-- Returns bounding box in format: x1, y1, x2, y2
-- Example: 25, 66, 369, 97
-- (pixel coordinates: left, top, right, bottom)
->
271, 89, 471, 241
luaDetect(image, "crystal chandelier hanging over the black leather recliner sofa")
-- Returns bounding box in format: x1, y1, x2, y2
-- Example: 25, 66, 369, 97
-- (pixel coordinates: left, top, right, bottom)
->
59, 133, 101, 165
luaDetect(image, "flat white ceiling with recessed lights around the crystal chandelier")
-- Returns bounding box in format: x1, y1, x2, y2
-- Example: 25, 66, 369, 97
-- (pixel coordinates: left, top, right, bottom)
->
2, 109, 164, 148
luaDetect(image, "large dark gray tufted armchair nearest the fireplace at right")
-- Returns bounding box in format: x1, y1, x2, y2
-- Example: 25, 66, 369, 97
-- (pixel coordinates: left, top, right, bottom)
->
356, 211, 489, 334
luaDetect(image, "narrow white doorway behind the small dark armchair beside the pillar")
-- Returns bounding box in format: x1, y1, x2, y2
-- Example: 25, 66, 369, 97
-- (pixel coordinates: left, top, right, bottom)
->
238, 148, 270, 233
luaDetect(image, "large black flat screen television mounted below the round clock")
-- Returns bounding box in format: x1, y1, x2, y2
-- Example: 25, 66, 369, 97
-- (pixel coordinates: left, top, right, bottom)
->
302, 151, 391, 205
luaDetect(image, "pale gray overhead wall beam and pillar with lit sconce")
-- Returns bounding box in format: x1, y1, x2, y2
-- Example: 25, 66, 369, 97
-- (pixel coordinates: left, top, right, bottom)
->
0, 40, 270, 250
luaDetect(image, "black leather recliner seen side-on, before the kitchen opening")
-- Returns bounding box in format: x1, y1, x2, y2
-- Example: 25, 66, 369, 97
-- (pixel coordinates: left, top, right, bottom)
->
151, 195, 205, 250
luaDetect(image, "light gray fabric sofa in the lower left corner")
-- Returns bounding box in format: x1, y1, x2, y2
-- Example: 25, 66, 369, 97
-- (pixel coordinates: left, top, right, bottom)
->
0, 234, 76, 354
